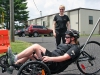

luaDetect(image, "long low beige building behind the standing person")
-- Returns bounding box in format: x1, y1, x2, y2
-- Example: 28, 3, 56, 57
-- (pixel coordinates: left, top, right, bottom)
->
28, 8, 100, 34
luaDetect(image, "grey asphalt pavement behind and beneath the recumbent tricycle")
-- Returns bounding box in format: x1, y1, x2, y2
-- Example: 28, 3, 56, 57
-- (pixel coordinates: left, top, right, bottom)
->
0, 36, 100, 75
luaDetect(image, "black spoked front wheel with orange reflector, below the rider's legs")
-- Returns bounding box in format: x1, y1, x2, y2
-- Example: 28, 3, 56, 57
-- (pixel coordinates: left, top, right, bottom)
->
17, 61, 51, 75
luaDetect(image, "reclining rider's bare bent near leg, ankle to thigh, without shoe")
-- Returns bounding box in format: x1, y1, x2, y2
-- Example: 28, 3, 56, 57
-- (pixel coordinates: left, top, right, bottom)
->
16, 44, 46, 59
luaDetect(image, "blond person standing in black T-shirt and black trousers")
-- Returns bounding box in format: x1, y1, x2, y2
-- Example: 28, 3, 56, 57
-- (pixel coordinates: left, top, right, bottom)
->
53, 5, 70, 46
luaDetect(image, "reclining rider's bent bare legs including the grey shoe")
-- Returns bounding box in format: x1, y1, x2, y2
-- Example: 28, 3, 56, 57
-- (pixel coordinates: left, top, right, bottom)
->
8, 44, 46, 65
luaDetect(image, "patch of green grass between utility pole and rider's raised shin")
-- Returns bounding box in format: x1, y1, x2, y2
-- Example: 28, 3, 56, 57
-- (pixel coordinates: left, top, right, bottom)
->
11, 41, 32, 53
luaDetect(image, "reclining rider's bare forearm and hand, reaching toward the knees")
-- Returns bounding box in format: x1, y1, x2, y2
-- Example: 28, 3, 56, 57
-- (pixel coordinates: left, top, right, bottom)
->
43, 53, 71, 62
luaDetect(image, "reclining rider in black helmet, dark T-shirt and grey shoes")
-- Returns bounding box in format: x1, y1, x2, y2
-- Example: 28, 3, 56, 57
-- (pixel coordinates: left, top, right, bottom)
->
8, 29, 80, 74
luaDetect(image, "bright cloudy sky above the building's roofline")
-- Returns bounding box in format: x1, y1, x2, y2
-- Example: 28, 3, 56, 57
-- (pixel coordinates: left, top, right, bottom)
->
27, 0, 100, 20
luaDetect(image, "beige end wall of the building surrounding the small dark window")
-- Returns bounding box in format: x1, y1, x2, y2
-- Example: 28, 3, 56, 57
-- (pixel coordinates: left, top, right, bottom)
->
80, 9, 100, 35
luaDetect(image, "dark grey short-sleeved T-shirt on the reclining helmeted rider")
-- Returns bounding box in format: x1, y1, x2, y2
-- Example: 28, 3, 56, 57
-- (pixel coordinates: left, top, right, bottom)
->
52, 44, 80, 59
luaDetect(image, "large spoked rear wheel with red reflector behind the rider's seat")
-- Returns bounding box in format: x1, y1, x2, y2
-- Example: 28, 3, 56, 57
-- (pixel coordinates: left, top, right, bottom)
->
77, 41, 100, 75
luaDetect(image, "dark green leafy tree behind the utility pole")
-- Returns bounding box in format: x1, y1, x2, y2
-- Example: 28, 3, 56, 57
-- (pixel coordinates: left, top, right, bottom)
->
0, 0, 29, 29
